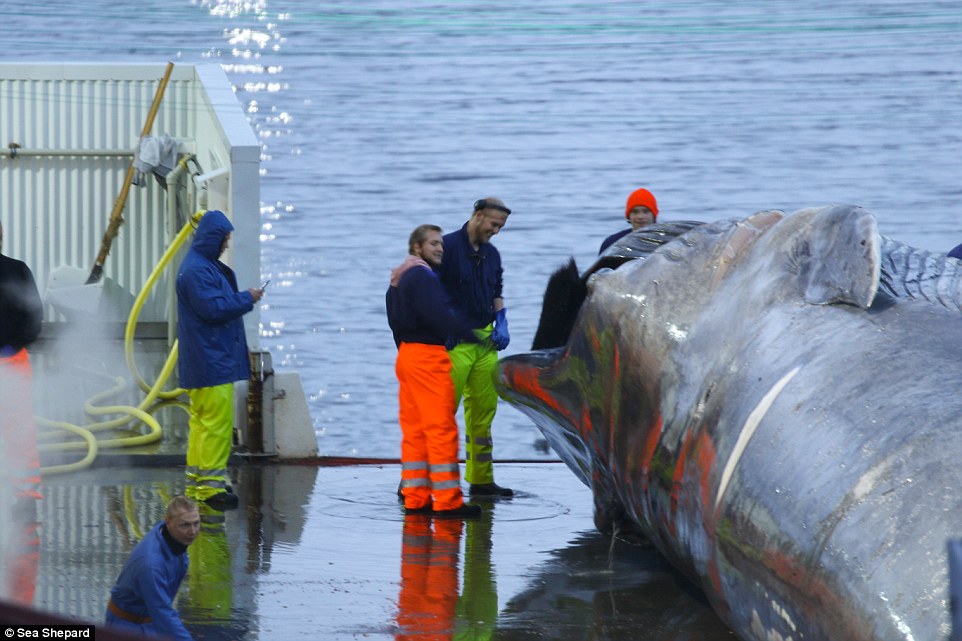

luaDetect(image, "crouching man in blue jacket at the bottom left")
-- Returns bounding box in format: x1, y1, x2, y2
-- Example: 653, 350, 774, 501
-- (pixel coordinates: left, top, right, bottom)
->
106, 496, 200, 641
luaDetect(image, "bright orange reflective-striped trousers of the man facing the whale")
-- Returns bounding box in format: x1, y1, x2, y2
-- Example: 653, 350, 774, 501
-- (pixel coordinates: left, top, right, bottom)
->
395, 343, 464, 510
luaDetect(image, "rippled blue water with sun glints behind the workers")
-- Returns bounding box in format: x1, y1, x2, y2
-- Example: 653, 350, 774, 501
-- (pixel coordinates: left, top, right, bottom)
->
0, 0, 962, 458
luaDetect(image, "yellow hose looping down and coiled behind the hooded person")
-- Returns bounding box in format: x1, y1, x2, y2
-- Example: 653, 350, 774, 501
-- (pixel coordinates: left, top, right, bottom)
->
36, 212, 203, 476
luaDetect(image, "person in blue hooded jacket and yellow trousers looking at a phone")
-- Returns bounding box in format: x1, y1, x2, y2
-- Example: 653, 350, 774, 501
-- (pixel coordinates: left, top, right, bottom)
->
177, 210, 264, 510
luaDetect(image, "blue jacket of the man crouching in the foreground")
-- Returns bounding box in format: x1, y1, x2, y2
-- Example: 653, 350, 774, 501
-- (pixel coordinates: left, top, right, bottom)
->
106, 522, 193, 641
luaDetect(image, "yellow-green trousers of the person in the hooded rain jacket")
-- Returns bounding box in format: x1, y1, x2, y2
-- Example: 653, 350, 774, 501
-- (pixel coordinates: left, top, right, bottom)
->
184, 383, 234, 501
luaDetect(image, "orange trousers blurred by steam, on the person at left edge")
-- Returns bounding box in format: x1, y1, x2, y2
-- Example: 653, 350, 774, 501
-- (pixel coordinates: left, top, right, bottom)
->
0, 349, 40, 498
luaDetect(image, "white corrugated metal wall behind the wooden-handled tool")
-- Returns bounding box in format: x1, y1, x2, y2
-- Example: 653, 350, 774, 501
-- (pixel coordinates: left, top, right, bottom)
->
0, 64, 260, 347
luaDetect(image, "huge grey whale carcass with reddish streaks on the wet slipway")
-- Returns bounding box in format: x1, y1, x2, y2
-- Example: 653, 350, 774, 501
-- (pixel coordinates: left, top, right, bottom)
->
497, 205, 962, 641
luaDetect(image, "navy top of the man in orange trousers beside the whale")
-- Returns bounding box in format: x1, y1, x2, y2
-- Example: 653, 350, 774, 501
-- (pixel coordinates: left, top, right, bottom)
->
385, 266, 477, 347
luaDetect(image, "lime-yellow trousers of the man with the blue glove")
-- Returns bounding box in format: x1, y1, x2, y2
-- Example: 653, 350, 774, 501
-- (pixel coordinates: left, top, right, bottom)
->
448, 336, 498, 485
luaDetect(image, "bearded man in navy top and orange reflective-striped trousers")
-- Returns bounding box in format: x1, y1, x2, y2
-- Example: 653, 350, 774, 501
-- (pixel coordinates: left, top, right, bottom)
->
385, 225, 481, 518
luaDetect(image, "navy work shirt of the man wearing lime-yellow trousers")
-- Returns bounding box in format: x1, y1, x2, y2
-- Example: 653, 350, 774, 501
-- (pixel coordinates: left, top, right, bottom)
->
439, 223, 504, 329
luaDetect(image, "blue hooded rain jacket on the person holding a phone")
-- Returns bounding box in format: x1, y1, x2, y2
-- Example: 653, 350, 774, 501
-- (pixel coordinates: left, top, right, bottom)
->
177, 210, 254, 389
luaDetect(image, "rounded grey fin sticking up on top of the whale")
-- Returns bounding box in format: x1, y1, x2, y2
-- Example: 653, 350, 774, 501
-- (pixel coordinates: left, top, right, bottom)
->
795, 205, 881, 308
